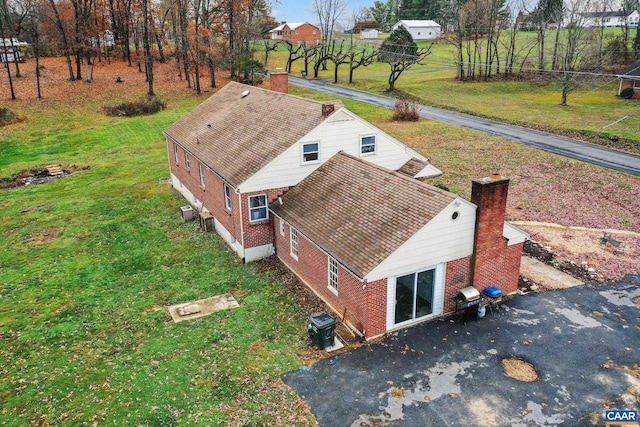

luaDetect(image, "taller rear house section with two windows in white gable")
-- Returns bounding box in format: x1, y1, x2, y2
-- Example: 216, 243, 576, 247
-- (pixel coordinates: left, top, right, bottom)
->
165, 73, 442, 262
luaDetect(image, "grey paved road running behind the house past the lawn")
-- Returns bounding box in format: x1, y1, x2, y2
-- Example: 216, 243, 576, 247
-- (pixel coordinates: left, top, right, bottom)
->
289, 76, 640, 176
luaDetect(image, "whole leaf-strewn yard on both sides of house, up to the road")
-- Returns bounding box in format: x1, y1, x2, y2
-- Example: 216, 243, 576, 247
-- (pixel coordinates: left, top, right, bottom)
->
0, 59, 640, 426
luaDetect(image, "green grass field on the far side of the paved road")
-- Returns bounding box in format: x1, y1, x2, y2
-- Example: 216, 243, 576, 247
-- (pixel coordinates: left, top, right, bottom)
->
268, 29, 640, 148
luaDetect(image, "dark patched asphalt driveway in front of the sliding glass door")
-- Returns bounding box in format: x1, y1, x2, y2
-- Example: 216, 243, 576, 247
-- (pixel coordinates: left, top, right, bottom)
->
282, 276, 640, 427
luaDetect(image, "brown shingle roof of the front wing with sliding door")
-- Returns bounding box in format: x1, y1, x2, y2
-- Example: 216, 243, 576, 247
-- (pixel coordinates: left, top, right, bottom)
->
271, 152, 457, 278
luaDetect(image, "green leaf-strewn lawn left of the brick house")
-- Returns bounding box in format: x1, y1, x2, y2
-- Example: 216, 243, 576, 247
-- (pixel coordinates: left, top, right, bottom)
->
0, 65, 314, 426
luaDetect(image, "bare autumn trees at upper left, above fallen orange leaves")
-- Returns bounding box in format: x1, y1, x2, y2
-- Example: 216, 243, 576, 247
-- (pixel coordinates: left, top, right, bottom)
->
0, 0, 277, 98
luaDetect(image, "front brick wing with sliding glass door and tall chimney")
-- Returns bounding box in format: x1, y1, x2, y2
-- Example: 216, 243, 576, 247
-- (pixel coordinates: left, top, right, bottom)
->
270, 152, 528, 339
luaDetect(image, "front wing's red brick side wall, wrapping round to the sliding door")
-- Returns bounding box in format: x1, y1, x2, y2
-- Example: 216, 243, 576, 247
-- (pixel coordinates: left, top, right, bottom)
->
274, 217, 387, 337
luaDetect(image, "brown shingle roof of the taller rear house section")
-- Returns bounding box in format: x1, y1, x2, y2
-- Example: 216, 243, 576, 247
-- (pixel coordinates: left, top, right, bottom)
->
165, 82, 342, 187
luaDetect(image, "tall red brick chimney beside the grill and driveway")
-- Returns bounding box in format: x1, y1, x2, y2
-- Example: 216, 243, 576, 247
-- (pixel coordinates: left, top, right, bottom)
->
471, 173, 522, 294
